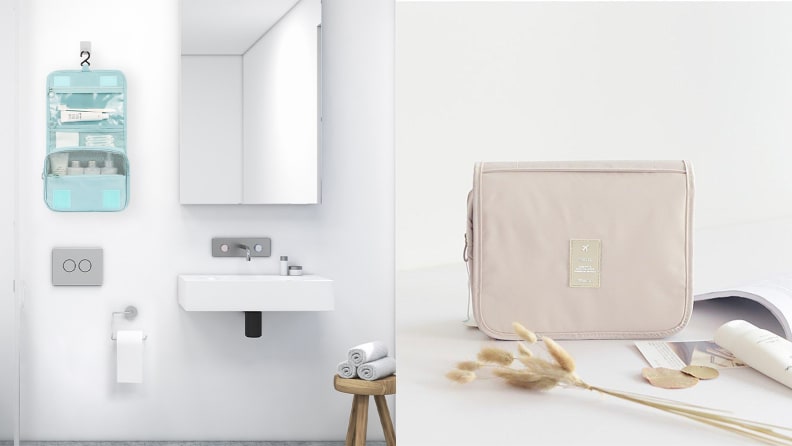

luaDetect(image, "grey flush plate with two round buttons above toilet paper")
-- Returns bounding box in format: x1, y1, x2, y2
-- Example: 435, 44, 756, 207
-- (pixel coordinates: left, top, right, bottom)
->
52, 248, 104, 286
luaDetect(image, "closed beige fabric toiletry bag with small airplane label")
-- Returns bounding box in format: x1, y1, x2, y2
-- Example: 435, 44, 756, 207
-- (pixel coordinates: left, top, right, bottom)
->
465, 161, 693, 340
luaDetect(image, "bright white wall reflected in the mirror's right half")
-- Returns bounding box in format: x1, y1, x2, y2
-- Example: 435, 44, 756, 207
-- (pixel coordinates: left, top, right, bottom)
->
243, 0, 322, 203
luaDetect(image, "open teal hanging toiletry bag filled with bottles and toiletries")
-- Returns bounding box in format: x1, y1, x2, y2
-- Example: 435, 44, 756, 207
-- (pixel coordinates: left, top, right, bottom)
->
43, 66, 129, 212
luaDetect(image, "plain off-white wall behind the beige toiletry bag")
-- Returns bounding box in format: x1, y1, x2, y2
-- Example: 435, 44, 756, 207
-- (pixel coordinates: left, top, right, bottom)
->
396, 2, 792, 269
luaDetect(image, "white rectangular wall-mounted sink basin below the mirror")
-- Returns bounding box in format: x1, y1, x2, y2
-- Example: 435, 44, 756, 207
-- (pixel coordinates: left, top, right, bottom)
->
178, 274, 334, 311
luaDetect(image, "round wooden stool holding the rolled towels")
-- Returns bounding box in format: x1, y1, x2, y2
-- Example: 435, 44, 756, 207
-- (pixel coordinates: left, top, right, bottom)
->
333, 375, 396, 446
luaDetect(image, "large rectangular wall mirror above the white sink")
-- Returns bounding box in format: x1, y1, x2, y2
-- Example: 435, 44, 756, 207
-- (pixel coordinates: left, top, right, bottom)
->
179, 0, 322, 204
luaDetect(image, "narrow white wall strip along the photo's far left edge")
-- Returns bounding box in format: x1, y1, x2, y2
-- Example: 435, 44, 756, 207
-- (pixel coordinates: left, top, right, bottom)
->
0, 0, 17, 441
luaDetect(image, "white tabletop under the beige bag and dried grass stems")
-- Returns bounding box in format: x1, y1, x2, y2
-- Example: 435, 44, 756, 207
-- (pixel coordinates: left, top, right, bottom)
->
396, 260, 792, 446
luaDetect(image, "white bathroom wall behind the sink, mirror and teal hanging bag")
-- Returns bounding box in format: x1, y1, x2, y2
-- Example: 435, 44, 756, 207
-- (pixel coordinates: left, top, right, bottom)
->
19, 0, 394, 440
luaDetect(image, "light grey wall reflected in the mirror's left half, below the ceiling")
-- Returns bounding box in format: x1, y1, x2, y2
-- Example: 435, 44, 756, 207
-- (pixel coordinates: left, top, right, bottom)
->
179, 55, 243, 204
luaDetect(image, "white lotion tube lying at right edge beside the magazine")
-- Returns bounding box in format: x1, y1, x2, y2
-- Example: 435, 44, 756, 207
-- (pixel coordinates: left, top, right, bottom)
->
715, 320, 792, 388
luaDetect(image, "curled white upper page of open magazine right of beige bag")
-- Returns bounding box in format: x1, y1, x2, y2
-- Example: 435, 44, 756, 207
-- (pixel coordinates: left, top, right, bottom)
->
694, 275, 792, 341
